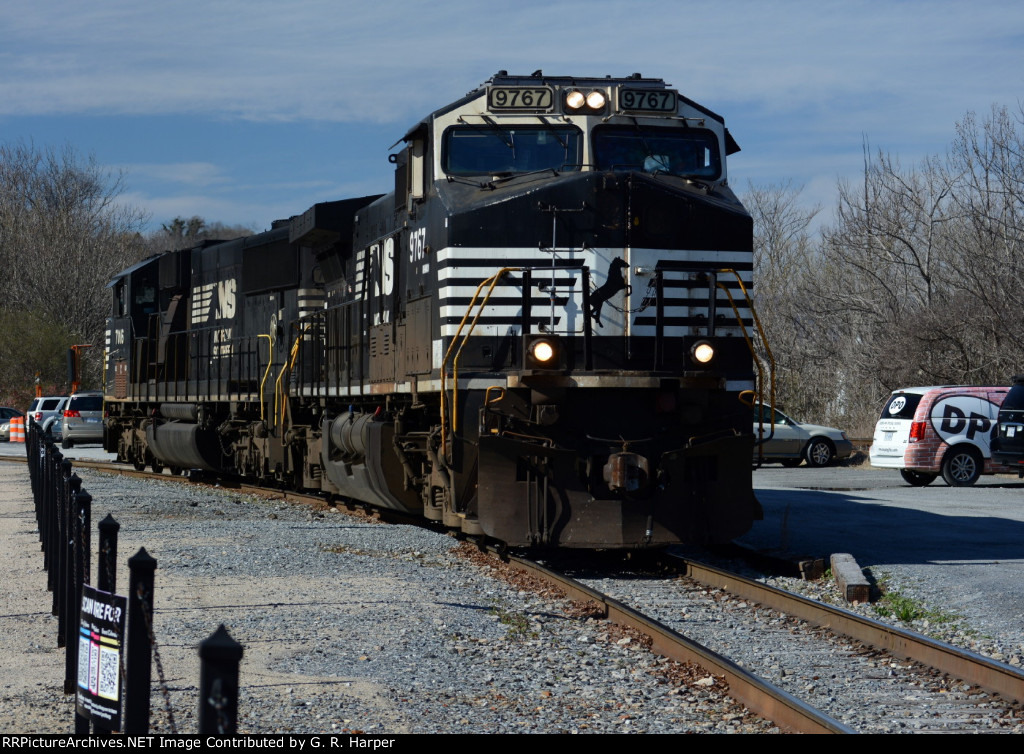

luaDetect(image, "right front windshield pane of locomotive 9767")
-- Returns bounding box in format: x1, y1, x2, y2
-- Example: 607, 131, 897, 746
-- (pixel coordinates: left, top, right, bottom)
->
593, 126, 722, 180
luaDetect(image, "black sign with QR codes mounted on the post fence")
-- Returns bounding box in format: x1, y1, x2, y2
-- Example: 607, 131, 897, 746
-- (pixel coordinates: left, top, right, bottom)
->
77, 584, 128, 730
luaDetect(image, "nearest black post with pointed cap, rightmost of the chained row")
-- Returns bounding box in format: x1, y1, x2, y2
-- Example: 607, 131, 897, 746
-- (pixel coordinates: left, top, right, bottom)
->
199, 624, 243, 736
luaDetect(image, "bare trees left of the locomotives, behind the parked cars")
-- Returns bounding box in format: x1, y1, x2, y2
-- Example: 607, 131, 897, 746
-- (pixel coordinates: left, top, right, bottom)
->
0, 142, 252, 410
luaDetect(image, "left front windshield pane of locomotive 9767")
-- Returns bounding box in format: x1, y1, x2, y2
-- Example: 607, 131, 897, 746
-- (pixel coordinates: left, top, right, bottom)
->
441, 128, 581, 175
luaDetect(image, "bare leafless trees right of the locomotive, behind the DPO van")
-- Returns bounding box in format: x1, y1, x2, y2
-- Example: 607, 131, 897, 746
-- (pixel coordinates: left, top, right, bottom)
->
743, 108, 1024, 436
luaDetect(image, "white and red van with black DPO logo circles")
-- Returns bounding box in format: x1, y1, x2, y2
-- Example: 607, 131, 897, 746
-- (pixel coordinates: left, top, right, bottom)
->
870, 385, 1013, 487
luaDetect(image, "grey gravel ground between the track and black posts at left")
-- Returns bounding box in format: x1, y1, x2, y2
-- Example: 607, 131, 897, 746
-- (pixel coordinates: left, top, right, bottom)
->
0, 463, 777, 734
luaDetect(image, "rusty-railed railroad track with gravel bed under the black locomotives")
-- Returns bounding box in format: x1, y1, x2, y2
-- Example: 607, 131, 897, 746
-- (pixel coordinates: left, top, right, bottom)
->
14, 450, 1024, 732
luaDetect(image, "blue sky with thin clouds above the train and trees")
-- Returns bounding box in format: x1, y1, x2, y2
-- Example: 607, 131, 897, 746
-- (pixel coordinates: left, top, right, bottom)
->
0, 0, 1024, 231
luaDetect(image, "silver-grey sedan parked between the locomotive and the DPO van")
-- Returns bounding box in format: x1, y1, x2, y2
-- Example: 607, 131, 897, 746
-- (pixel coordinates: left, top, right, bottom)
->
754, 404, 853, 466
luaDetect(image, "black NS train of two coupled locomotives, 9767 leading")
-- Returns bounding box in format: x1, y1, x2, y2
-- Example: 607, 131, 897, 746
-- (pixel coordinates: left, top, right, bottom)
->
104, 72, 761, 548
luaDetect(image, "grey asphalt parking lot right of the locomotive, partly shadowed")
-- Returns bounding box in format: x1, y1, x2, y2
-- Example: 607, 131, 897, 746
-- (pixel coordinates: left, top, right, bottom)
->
740, 465, 1024, 642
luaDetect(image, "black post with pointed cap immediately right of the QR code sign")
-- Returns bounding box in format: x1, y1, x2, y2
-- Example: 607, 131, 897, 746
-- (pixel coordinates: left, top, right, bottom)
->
123, 547, 157, 736
